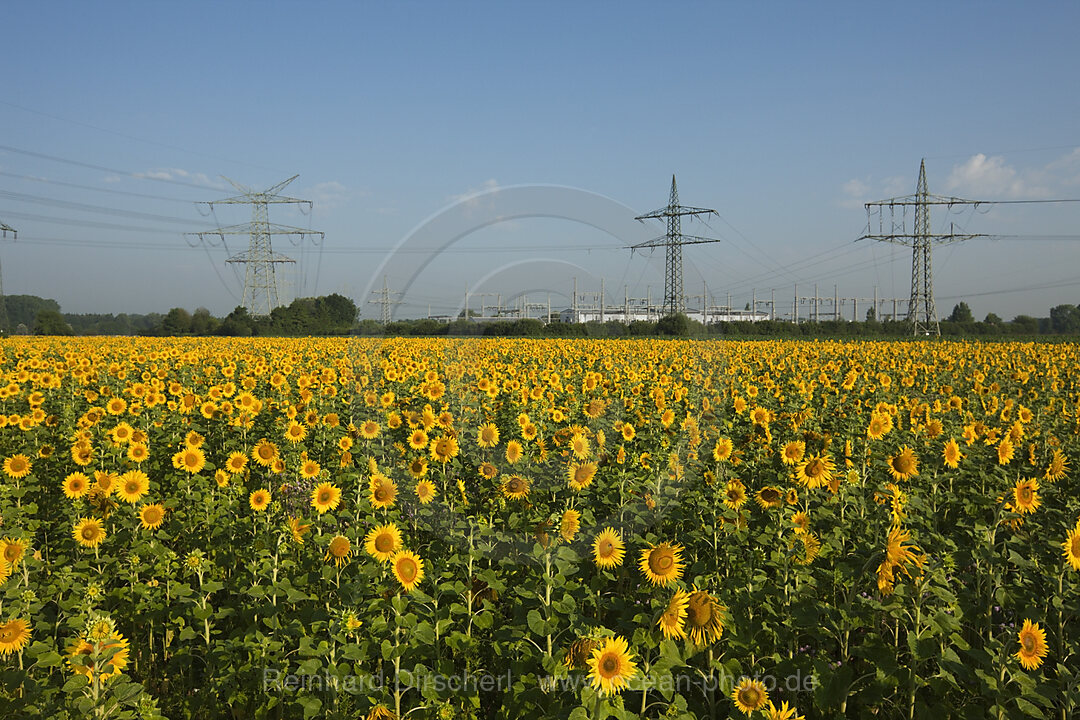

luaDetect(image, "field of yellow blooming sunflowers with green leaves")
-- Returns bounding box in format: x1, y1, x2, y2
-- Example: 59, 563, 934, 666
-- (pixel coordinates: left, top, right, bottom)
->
0, 338, 1080, 720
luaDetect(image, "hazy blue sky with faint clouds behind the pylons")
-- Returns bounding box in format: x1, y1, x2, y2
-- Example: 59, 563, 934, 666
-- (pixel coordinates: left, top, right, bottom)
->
0, 1, 1080, 318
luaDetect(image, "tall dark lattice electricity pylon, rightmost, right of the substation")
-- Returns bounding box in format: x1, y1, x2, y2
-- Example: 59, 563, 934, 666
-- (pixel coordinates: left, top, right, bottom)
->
859, 159, 986, 336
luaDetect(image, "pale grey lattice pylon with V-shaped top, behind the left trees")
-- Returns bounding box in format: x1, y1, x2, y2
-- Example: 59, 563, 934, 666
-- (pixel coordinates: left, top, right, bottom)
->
185, 175, 326, 317
